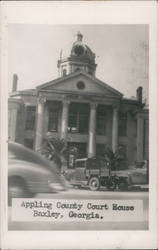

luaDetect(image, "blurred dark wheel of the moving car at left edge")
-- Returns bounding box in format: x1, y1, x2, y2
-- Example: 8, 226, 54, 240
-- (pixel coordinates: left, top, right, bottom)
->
8, 176, 31, 205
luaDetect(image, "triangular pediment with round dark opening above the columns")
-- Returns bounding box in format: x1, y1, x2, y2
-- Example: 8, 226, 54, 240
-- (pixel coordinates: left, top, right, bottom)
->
37, 72, 122, 97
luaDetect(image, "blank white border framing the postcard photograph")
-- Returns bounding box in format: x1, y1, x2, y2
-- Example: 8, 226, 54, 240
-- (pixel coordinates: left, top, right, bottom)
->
1, 1, 158, 249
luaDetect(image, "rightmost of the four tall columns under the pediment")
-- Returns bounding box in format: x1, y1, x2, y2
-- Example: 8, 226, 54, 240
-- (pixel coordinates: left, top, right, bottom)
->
112, 106, 118, 152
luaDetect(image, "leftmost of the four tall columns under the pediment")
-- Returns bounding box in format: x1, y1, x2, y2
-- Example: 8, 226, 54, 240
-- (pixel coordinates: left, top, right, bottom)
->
35, 97, 46, 151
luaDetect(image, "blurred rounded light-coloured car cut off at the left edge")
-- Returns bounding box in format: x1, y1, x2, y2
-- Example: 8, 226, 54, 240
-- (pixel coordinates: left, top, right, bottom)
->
8, 142, 66, 204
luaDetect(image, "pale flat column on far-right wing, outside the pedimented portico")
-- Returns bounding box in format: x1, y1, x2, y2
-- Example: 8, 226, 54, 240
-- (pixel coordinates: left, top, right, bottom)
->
137, 115, 144, 162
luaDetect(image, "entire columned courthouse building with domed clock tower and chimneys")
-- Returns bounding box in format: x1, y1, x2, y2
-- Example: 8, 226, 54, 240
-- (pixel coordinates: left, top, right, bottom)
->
8, 33, 148, 165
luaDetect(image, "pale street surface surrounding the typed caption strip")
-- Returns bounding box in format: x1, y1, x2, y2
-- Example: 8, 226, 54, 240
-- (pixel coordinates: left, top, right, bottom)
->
8, 188, 148, 230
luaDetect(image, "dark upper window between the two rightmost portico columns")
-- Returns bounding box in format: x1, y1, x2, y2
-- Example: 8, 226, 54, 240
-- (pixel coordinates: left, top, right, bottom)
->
96, 105, 106, 135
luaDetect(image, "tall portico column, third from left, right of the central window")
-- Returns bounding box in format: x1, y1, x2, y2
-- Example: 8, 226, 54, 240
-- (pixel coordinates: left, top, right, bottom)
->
88, 103, 97, 158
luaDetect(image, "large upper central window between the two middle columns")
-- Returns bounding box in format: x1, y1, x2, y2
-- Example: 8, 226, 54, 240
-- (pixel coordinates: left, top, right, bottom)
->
68, 103, 89, 134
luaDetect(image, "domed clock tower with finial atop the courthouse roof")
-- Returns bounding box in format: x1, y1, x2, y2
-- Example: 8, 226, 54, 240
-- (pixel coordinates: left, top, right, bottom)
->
58, 32, 97, 77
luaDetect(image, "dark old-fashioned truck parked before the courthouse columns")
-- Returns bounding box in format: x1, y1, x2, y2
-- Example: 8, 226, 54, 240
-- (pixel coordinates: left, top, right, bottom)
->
64, 158, 116, 191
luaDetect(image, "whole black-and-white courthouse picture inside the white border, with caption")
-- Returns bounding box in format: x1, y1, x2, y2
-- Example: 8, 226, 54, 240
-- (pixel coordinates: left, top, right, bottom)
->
2, 2, 157, 248
